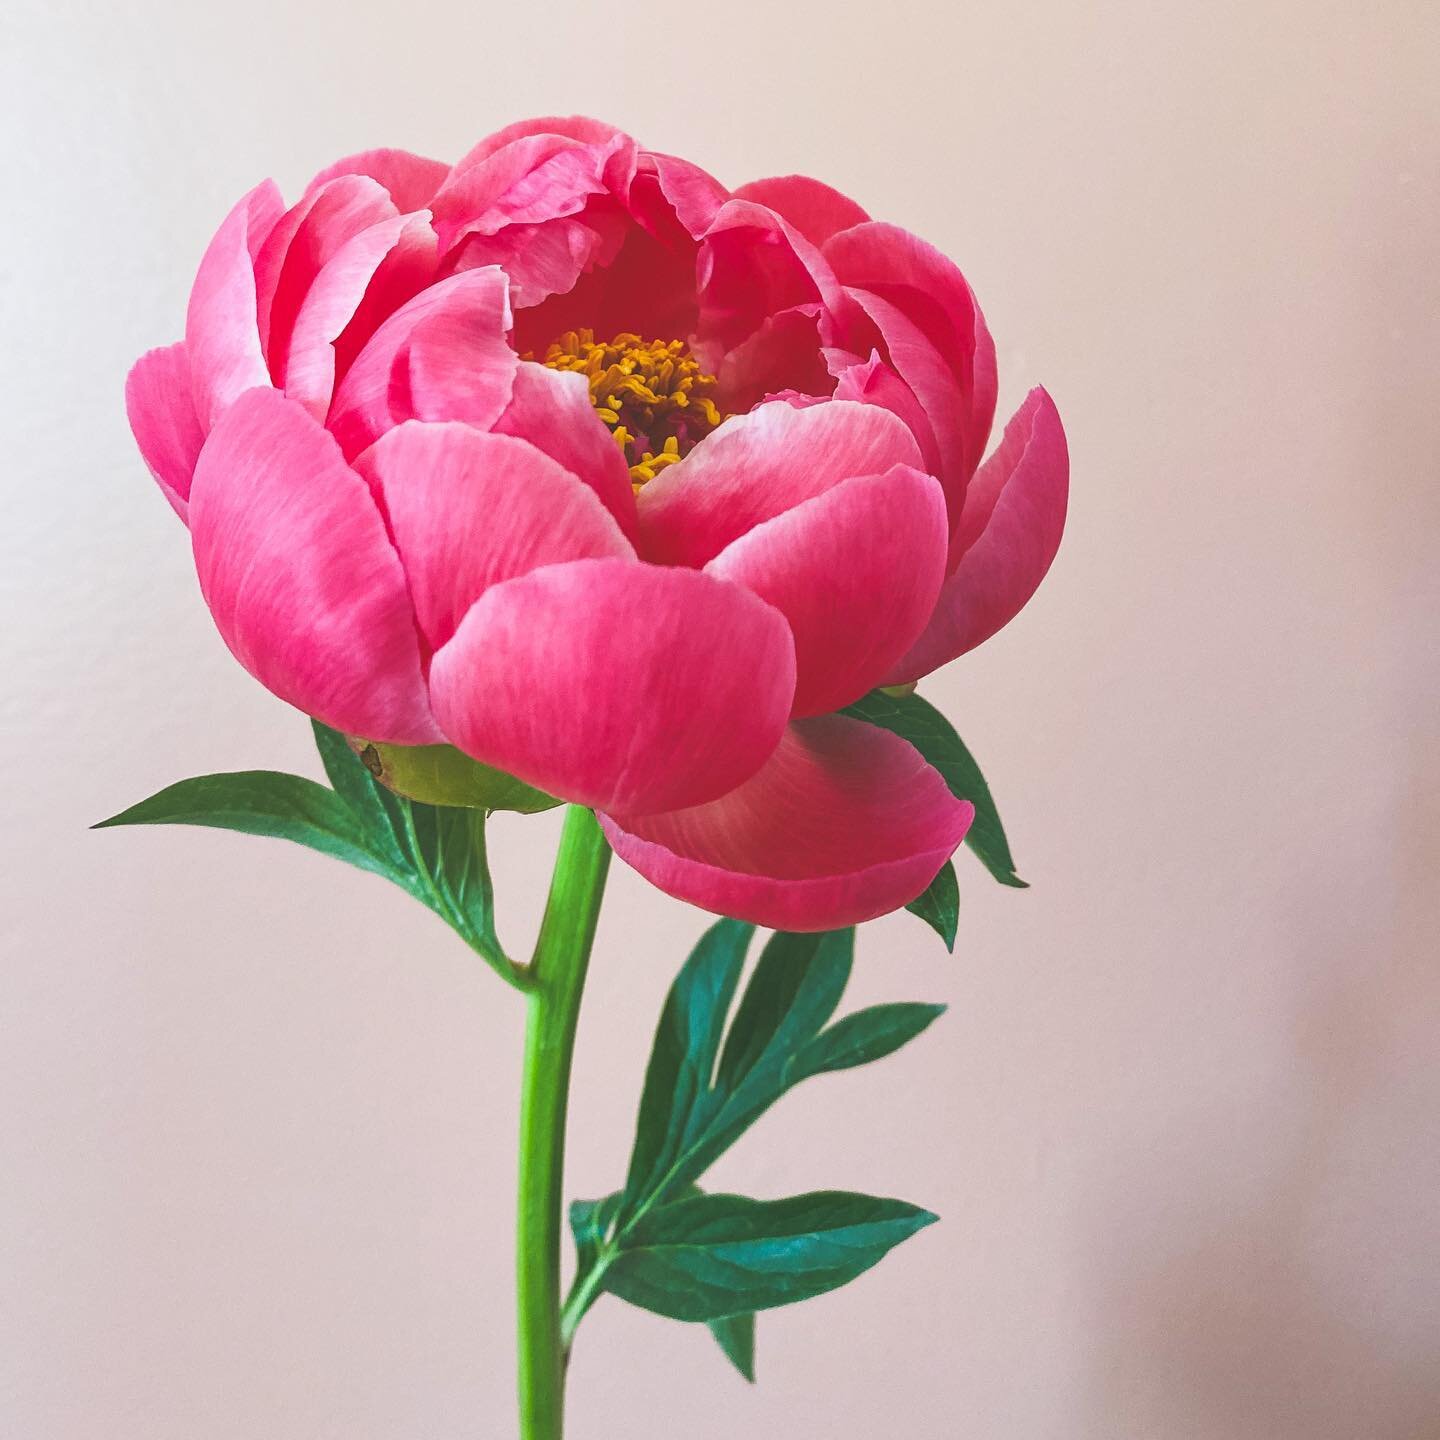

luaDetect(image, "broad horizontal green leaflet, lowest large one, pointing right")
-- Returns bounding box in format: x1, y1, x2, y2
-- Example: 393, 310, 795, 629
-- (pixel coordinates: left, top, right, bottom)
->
605, 1191, 937, 1322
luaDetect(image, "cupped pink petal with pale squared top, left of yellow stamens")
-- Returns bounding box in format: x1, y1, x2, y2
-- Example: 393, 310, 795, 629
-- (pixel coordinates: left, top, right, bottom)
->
327, 269, 518, 459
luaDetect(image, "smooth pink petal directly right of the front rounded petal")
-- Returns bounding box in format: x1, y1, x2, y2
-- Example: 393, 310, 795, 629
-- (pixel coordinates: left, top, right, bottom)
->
706, 465, 946, 716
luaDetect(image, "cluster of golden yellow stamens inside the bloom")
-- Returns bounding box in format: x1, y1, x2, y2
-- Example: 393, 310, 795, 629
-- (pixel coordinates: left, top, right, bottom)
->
526, 330, 726, 491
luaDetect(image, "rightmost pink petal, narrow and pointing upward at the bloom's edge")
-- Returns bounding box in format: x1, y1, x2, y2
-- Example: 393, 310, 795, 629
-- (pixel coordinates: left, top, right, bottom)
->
886, 389, 1070, 684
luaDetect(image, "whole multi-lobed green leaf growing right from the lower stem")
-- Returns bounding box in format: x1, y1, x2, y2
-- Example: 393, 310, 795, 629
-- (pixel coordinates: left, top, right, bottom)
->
563, 920, 943, 1347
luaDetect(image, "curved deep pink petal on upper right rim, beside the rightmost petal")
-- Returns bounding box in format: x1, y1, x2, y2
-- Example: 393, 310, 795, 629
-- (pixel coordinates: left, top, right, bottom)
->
825, 222, 995, 514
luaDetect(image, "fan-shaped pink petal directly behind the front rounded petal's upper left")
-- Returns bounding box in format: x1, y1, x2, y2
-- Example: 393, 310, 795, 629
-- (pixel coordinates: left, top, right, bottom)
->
356, 420, 635, 649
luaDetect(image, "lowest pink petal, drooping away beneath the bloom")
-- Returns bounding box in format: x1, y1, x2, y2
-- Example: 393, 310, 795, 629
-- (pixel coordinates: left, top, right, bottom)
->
602, 716, 975, 930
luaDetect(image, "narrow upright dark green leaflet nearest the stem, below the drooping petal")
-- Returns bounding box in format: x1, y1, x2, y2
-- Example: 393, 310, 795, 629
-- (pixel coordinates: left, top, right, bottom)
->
622, 920, 755, 1214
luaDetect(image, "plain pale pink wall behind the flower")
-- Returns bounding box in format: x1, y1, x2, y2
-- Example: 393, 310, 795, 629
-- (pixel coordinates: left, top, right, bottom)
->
0, 0, 1440, 1440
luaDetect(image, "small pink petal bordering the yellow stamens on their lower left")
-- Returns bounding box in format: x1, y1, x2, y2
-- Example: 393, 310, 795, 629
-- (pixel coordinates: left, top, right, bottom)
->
494, 364, 636, 537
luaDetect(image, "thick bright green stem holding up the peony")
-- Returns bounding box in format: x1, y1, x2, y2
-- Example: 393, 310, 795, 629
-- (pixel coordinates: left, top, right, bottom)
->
516, 805, 611, 1440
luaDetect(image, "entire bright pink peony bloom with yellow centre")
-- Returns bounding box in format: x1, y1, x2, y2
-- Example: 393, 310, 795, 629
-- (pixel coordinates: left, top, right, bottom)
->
127, 120, 1067, 930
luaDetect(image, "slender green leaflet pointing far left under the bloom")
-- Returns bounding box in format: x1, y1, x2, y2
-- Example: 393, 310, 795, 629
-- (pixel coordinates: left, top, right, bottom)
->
92, 770, 403, 884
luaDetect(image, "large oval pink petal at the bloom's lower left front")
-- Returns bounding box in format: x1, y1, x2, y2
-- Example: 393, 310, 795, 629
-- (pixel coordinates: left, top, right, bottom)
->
190, 389, 441, 744
